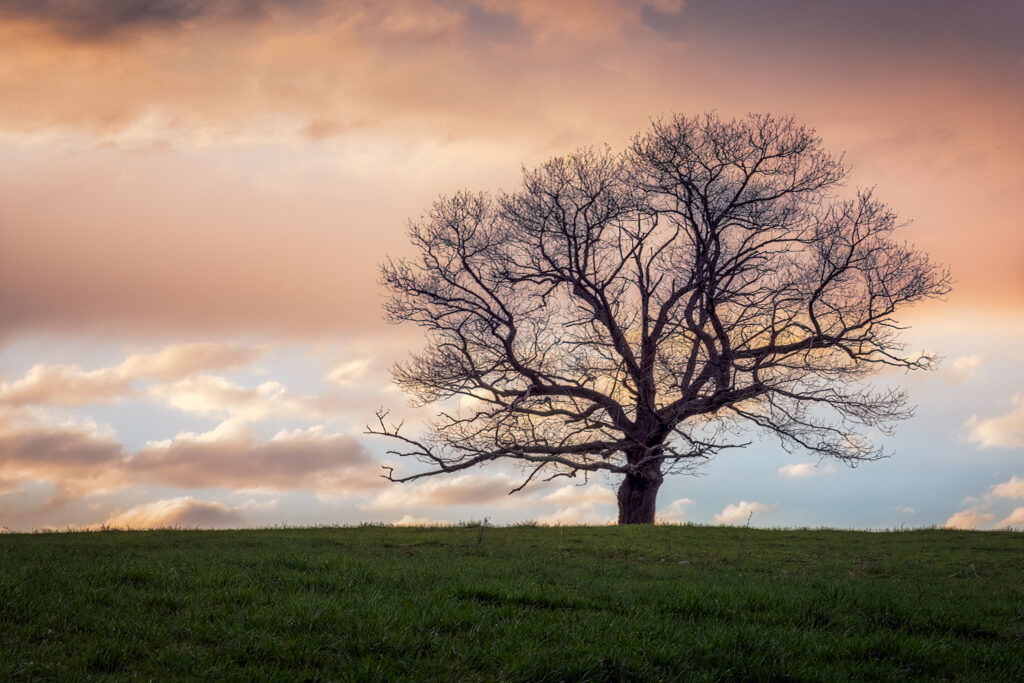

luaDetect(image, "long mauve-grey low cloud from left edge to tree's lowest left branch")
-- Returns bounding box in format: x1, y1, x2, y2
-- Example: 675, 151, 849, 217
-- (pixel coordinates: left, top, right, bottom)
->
0, 411, 385, 506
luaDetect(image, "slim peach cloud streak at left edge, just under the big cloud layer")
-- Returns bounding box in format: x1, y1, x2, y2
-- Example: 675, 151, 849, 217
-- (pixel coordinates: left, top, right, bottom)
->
0, 343, 263, 407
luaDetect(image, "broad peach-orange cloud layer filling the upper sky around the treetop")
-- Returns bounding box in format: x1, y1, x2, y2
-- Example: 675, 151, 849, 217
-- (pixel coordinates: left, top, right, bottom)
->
0, 0, 1024, 348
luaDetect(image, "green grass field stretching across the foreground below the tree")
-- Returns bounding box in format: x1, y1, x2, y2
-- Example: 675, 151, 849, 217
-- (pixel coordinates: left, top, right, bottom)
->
0, 526, 1024, 681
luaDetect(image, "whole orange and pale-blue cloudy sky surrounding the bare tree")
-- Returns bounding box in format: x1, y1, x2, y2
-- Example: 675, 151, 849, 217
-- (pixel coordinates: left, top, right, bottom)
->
0, 0, 1024, 531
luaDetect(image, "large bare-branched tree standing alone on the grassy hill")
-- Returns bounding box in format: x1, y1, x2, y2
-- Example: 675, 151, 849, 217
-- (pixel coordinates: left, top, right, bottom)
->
368, 115, 949, 523
